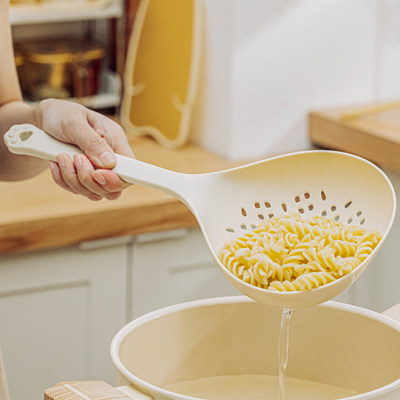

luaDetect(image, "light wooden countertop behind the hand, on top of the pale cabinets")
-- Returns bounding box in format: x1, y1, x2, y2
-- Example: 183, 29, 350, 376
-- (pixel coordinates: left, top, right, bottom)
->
0, 134, 238, 254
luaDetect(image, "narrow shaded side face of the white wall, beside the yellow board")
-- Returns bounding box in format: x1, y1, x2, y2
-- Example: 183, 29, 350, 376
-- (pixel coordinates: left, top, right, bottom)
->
191, 0, 234, 159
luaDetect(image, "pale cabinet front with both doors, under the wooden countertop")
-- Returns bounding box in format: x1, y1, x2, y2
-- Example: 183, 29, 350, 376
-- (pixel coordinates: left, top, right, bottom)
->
0, 230, 238, 400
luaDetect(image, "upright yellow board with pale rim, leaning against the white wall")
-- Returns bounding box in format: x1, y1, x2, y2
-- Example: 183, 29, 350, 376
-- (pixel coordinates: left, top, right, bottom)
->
121, 0, 203, 148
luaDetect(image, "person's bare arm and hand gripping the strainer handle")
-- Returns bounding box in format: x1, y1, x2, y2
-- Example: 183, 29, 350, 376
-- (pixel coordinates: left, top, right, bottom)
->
0, 0, 134, 200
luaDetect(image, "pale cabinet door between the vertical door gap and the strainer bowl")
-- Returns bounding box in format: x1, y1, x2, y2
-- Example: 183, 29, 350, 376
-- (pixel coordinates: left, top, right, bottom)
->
130, 230, 240, 318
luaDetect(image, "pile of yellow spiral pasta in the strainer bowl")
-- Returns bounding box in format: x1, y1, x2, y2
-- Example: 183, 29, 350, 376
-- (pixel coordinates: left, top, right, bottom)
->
219, 213, 382, 292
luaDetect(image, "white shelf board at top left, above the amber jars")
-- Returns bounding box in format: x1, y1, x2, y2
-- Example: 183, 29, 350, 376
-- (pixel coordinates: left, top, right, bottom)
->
10, 0, 123, 25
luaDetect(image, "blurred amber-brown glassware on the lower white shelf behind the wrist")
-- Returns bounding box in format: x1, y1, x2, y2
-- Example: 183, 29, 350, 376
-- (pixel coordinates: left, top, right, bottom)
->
15, 33, 121, 110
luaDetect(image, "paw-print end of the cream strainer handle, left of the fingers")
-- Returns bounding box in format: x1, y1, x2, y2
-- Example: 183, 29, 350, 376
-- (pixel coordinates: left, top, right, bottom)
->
4, 124, 83, 161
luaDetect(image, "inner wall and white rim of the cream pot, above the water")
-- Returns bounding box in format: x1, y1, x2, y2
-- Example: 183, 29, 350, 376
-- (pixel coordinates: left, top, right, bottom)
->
111, 296, 400, 400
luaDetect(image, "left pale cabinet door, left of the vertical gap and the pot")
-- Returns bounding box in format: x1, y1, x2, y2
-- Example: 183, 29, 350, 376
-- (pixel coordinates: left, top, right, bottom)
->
0, 246, 127, 400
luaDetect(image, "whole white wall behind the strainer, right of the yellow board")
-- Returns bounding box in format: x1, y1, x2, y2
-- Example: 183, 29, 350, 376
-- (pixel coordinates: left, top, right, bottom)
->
193, 0, 400, 160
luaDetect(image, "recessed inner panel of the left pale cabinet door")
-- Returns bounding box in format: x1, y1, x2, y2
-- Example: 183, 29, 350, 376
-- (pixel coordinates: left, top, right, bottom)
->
0, 282, 90, 399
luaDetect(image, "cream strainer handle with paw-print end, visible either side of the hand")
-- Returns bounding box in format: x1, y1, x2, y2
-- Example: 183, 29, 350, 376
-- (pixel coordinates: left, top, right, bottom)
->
4, 124, 185, 198
